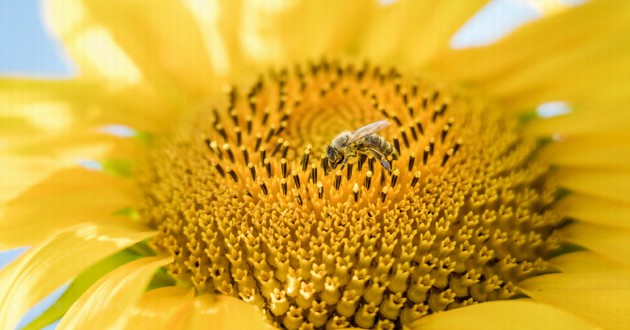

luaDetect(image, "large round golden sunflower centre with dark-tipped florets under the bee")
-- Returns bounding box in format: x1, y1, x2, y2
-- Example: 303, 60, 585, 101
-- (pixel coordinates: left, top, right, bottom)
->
141, 61, 561, 329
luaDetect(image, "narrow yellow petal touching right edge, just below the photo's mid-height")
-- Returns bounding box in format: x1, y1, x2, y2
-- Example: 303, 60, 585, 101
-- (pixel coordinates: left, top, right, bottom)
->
556, 169, 630, 203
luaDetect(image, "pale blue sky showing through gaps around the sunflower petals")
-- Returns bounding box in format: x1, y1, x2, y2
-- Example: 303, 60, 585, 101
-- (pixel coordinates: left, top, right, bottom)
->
0, 0, 552, 329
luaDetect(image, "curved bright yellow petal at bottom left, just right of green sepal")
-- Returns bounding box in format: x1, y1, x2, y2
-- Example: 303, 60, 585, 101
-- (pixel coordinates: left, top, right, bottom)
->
59, 257, 169, 329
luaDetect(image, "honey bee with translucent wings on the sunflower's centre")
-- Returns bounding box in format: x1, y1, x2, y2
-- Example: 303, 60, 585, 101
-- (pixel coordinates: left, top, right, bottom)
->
326, 119, 397, 171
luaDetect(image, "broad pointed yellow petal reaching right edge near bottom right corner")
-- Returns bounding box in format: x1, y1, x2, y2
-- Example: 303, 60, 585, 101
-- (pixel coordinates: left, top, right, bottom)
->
518, 273, 630, 329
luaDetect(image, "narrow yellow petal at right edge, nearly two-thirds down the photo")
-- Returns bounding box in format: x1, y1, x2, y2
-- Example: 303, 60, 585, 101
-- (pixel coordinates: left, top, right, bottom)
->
558, 194, 630, 230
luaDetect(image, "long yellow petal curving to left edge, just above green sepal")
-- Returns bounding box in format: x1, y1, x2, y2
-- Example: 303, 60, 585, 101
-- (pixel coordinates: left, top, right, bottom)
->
0, 223, 154, 329
